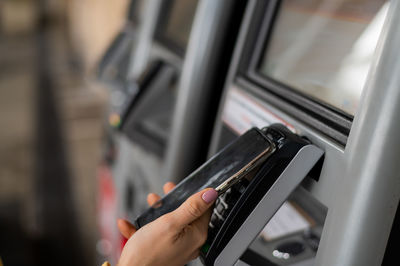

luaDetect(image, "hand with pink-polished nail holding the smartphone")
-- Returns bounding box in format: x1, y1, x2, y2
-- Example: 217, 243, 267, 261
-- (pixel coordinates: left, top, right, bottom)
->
117, 182, 215, 266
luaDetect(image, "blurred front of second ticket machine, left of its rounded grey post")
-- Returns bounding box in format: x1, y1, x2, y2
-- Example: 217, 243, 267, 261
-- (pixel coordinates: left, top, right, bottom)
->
109, 0, 197, 227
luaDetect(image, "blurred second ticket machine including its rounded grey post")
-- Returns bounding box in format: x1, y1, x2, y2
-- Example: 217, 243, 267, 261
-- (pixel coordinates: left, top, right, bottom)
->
113, 0, 245, 225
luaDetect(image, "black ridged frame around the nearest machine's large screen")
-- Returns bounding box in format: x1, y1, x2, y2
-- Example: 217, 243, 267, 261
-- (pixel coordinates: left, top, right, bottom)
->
235, 0, 353, 146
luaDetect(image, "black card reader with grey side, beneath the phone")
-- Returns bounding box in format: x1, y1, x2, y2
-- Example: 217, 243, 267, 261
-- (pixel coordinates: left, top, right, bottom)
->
200, 124, 324, 266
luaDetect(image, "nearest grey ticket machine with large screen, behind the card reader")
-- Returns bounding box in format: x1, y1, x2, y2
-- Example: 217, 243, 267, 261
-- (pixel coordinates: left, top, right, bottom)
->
205, 0, 400, 266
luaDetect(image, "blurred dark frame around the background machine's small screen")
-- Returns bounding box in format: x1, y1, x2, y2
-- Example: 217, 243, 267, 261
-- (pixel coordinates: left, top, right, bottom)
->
154, 0, 198, 57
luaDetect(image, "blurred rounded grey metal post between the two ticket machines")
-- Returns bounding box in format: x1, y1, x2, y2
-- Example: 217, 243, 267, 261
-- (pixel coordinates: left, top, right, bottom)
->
164, 0, 238, 180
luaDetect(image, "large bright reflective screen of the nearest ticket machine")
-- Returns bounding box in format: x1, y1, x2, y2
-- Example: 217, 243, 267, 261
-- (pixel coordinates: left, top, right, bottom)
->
259, 0, 388, 115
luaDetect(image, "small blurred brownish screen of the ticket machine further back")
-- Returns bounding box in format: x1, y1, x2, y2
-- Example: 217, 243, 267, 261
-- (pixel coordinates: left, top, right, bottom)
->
165, 0, 198, 49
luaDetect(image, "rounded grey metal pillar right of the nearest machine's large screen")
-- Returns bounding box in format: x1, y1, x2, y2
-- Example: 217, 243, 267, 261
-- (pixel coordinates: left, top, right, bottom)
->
316, 1, 400, 266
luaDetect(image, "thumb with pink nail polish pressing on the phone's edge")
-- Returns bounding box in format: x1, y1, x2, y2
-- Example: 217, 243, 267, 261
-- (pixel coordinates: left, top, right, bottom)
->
172, 188, 218, 226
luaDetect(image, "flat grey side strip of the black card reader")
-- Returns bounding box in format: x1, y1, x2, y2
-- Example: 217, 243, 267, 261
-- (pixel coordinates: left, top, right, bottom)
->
214, 145, 324, 266
